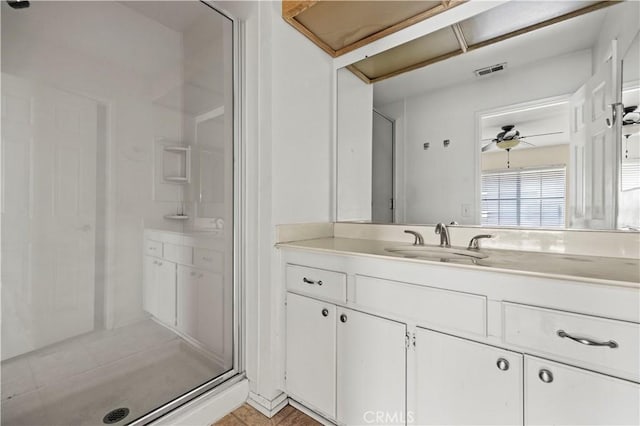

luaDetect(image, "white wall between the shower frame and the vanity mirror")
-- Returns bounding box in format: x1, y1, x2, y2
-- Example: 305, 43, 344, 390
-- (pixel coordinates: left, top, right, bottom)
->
217, 1, 333, 407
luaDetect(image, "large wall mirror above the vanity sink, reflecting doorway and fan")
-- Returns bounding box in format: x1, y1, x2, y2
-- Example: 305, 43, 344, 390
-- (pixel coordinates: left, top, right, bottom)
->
336, 1, 640, 231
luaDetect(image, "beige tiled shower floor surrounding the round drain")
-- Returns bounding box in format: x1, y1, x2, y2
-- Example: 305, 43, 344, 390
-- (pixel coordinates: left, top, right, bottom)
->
2, 320, 225, 426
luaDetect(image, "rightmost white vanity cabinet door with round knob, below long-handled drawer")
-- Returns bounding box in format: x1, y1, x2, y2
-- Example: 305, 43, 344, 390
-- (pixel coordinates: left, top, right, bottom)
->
525, 356, 640, 425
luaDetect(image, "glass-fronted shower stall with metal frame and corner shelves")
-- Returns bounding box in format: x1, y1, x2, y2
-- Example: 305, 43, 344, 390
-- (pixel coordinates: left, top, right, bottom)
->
0, 1, 241, 426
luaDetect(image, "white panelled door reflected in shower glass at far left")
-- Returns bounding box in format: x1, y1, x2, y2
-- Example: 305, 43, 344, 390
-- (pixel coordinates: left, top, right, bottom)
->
2, 73, 98, 359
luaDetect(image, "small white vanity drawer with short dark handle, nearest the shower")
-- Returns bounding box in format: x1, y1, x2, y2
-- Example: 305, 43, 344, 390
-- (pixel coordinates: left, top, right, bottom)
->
287, 265, 347, 302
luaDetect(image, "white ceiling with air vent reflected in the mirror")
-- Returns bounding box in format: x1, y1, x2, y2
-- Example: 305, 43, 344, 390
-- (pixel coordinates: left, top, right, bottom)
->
373, 8, 608, 107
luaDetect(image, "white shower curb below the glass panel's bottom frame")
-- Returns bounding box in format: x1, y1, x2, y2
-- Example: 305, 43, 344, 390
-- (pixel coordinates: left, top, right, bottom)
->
151, 378, 249, 426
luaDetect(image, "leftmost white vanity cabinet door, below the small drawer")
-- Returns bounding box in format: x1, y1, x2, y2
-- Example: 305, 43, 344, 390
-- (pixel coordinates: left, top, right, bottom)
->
285, 293, 336, 418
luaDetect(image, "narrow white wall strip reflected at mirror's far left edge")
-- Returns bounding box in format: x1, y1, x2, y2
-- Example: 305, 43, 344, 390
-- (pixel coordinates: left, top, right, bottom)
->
337, 68, 373, 221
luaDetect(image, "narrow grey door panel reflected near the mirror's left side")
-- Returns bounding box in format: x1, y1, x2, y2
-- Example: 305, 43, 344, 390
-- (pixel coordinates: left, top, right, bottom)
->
371, 111, 395, 223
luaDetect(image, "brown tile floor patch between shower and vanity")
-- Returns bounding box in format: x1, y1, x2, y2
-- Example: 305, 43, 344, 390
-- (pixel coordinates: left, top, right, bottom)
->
212, 404, 322, 426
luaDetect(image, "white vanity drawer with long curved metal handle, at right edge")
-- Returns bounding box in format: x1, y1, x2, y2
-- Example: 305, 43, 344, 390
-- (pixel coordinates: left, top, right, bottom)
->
503, 303, 640, 381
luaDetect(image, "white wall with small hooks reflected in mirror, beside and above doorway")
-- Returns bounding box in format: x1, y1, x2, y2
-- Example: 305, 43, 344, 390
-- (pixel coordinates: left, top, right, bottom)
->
381, 50, 591, 224
